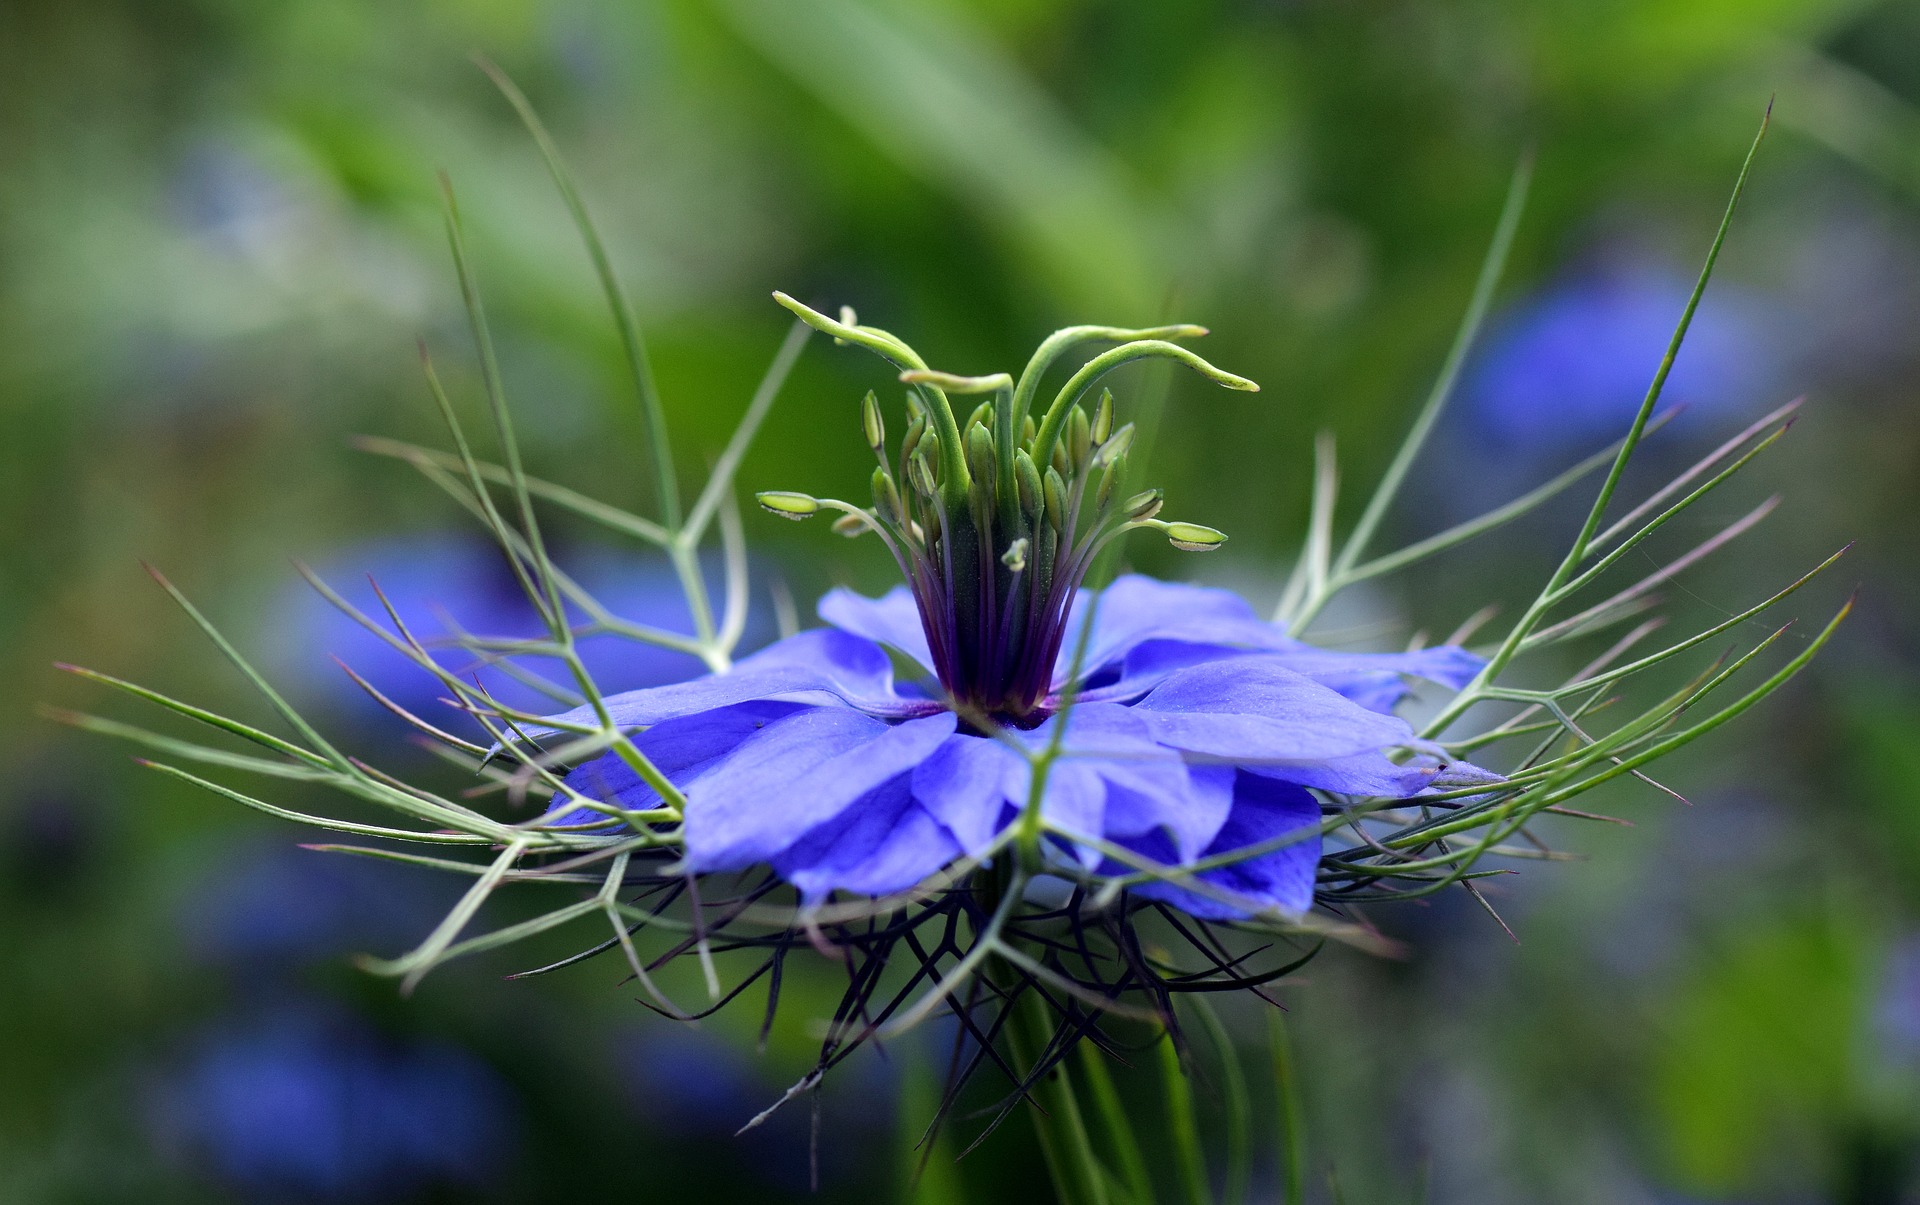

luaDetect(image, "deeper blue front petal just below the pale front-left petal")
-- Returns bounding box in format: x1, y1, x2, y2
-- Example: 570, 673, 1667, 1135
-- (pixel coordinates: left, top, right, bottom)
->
774, 773, 960, 904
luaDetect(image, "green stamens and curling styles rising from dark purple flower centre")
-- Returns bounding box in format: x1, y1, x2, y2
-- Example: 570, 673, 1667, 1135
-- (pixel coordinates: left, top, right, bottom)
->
758, 294, 1258, 725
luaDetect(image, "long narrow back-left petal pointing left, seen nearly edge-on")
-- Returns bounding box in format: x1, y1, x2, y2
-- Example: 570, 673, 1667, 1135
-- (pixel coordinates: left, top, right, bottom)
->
528, 627, 931, 735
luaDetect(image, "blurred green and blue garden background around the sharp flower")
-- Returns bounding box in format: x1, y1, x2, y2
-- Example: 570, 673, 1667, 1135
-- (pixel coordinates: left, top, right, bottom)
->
0, 0, 1920, 1203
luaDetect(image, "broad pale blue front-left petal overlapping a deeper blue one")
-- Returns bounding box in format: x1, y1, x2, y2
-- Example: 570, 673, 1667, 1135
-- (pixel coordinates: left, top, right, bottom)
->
685, 706, 954, 871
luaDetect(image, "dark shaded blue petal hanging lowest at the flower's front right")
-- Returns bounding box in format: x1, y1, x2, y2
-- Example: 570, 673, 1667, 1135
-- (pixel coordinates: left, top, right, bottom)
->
1133, 773, 1321, 921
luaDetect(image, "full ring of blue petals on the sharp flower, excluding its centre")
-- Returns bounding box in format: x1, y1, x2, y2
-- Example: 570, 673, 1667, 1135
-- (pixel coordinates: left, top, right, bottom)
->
555, 576, 1486, 917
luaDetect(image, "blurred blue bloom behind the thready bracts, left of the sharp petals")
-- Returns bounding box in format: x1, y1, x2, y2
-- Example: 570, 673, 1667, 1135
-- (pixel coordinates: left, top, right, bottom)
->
273, 533, 772, 727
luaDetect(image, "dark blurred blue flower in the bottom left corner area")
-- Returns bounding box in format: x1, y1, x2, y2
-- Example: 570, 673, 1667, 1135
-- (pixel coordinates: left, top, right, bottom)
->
154, 1004, 518, 1201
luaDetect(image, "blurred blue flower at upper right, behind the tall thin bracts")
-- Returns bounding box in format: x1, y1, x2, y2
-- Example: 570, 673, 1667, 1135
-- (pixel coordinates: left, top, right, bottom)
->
1461, 253, 1784, 461
